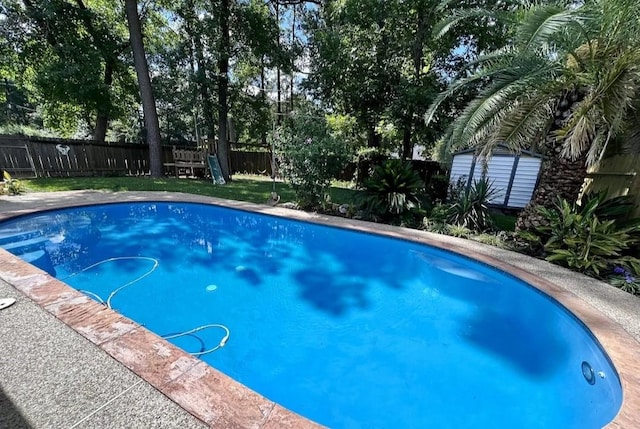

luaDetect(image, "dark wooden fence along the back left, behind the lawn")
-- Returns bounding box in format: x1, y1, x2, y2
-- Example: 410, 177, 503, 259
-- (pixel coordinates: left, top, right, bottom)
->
0, 136, 271, 178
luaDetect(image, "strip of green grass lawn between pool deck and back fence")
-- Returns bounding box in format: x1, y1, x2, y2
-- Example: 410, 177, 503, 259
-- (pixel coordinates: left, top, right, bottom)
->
20, 174, 355, 204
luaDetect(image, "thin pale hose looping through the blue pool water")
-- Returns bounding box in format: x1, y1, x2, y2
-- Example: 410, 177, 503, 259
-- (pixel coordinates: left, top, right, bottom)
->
62, 256, 231, 357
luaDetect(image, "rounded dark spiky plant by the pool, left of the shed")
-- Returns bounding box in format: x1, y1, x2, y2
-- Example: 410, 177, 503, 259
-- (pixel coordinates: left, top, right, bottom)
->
358, 159, 424, 222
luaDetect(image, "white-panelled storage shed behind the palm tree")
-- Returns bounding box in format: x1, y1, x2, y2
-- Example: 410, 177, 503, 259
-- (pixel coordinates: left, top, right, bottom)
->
449, 146, 542, 209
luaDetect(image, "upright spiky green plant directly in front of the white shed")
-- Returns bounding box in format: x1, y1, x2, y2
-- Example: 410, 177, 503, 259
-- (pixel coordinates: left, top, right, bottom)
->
447, 178, 495, 231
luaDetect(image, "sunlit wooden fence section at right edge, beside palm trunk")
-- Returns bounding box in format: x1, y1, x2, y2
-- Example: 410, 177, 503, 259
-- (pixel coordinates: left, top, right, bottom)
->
583, 154, 640, 216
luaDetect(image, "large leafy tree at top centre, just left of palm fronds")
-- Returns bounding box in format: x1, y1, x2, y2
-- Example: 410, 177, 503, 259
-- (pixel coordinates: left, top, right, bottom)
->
306, 0, 505, 157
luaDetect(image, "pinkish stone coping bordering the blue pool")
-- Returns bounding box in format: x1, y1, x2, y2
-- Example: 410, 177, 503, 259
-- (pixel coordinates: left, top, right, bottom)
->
0, 191, 640, 429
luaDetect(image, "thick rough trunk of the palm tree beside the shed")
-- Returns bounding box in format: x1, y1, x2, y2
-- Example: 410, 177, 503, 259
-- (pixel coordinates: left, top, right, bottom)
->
516, 92, 587, 231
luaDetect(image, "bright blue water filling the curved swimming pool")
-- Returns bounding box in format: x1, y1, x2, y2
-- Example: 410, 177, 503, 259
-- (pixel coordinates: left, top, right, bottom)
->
0, 203, 622, 429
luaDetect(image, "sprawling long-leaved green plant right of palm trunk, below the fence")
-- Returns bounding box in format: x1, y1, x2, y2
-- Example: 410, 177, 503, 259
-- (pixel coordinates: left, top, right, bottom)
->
536, 195, 639, 276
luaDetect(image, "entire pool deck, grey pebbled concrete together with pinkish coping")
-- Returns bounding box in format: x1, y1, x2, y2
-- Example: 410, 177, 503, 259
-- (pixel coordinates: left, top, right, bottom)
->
0, 191, 640, 429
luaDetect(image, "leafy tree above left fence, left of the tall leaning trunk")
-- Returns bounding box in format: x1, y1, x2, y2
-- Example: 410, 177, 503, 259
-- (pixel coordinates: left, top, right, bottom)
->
6, 0, 134, 141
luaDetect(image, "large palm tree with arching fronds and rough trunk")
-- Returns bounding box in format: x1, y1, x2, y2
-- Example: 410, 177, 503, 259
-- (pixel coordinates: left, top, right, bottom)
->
427, 0, 640, 229
